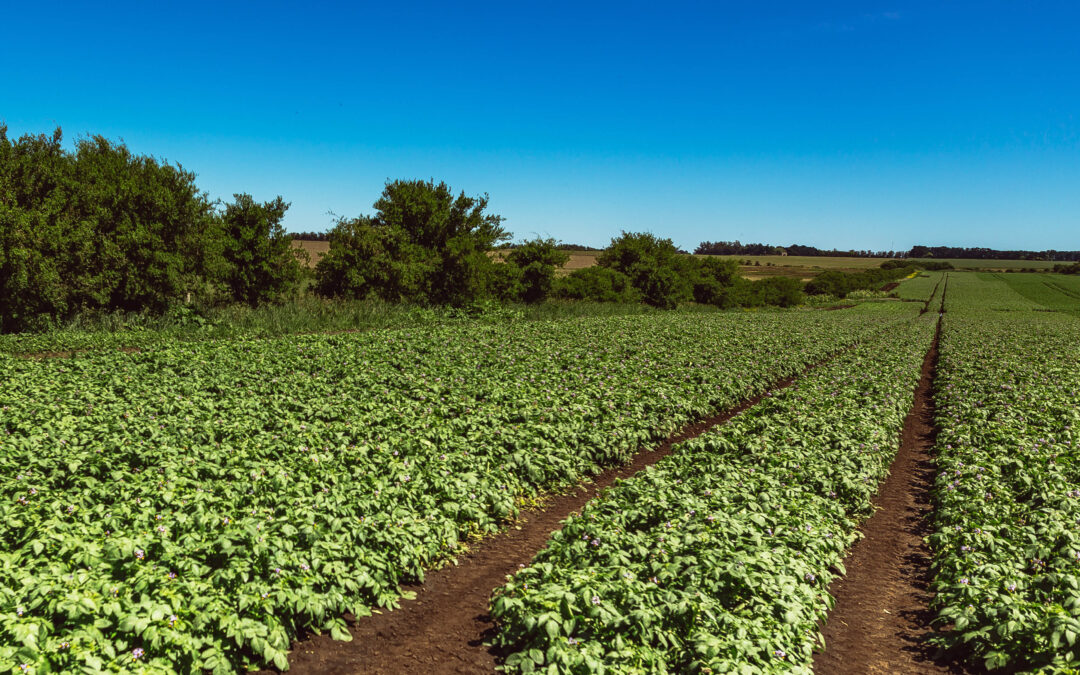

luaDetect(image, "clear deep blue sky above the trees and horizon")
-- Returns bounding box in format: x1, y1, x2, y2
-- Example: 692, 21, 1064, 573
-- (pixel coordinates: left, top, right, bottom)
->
0, 0, 1080, 249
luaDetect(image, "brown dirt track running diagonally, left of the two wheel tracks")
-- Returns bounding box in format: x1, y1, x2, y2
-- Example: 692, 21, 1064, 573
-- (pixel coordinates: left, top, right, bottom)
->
267, 352, 842, 675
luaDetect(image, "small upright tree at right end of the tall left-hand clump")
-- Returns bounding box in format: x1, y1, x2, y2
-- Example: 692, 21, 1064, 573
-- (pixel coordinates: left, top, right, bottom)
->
221, 193, 303, 306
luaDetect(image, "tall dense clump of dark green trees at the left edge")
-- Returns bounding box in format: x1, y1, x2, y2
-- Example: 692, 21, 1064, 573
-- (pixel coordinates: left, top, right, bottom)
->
0, 125, 302, 332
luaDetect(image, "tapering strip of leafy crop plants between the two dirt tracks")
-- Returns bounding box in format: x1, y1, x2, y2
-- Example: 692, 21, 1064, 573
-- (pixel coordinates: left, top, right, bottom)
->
491, 303, 936, 673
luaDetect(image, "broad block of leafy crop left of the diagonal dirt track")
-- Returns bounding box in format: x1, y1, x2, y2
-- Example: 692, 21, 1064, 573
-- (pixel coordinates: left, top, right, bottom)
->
0, 302, 913, 673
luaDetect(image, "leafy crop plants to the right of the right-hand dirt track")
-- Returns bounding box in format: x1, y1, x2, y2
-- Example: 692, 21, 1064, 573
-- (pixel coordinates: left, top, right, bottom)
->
930, 279, 1080, 673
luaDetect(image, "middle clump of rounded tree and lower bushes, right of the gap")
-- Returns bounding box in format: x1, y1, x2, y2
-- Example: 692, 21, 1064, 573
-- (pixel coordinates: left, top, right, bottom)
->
314, 180, 802, 309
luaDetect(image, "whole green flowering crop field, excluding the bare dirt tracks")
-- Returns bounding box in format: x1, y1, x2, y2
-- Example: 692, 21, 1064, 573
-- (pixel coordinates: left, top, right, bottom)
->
0, 272, 1080, 673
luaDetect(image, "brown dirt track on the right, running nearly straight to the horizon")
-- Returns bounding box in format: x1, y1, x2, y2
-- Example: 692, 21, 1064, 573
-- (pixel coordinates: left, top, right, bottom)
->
813, 278, 971, 675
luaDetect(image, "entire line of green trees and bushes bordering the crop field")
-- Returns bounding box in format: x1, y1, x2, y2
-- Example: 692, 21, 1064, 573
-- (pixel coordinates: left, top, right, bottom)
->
0, 125, 972, 332
